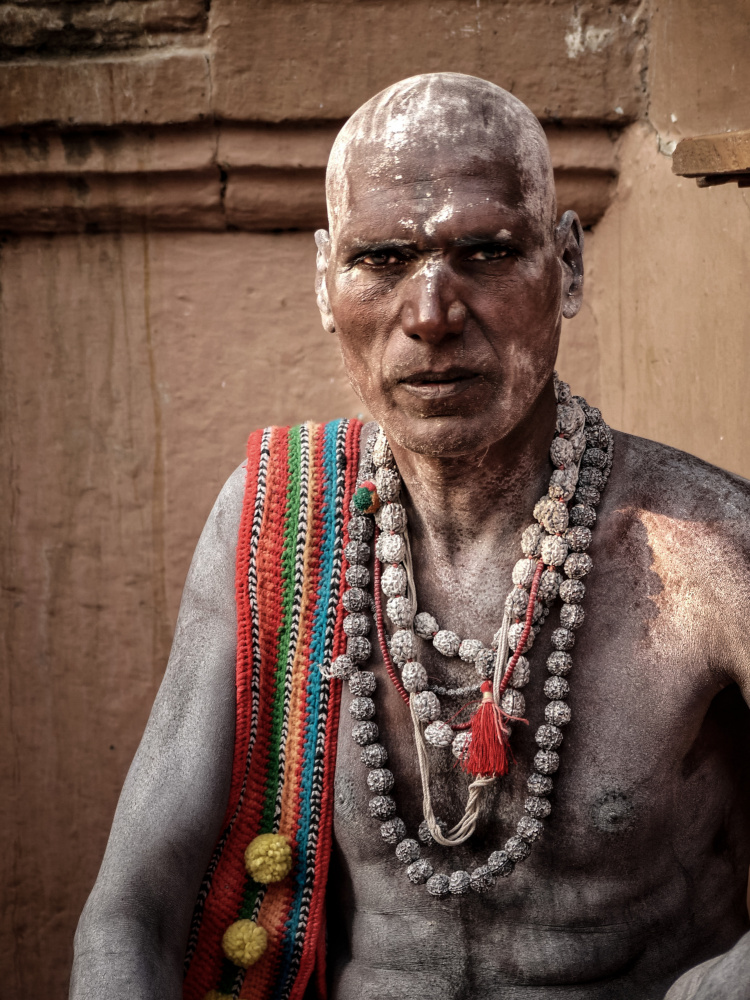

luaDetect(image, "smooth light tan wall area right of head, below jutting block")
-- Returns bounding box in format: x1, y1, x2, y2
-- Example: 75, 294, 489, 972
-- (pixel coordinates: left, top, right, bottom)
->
572, 124, 750, 477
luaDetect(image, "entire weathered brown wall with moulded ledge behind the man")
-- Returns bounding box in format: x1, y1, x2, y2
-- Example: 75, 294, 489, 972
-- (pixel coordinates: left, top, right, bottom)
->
0, 0, 750, 1000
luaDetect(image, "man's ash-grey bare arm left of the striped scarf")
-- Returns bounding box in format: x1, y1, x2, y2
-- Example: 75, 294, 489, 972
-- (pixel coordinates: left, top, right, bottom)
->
70, 468, 245, 1000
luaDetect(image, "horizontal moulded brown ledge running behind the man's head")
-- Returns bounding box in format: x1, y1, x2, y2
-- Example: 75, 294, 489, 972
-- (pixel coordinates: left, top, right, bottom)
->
0, 123, 617, 233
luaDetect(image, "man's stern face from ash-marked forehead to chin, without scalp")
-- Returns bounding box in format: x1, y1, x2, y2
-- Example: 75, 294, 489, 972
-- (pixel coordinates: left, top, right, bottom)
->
326, 146, 576, 456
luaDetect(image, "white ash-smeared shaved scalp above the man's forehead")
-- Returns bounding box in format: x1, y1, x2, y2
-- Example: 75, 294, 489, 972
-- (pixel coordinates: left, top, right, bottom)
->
326, 73, 556, 238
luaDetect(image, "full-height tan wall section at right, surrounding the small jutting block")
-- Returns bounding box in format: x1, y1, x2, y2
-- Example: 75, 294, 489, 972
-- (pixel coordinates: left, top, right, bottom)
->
560, 0, 750, 477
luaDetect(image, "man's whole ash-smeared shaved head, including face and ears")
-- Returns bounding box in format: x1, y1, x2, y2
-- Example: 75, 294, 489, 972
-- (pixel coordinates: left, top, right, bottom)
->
316, 74, 583, 457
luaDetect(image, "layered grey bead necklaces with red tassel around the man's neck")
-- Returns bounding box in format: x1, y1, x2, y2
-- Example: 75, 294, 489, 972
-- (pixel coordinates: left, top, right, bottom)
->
320, 374, 613, 898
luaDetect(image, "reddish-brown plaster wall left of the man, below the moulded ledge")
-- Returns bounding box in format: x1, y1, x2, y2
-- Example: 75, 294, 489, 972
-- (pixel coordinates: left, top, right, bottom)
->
0, 233, 357, 1000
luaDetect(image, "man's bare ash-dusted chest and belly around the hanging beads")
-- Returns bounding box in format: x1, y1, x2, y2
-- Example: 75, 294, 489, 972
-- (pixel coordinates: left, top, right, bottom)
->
334, 536, 750, 997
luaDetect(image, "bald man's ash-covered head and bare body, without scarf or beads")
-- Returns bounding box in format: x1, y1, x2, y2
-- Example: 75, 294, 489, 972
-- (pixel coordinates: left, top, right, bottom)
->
72, 74, 750, 1000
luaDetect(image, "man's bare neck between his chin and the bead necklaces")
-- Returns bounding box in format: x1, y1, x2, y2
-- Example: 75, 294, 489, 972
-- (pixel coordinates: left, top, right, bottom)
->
393, 385, 556, 548
